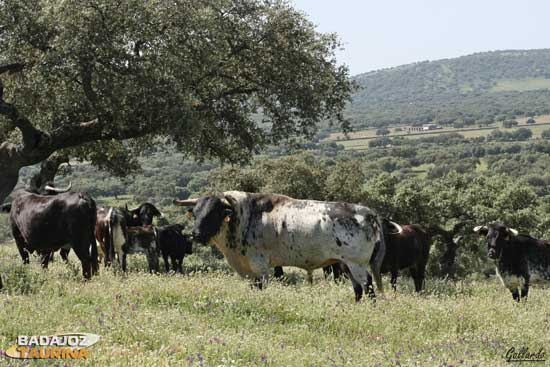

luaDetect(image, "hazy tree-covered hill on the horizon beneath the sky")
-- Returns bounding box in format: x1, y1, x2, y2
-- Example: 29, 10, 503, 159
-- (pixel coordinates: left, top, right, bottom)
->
347, 49, 550, 128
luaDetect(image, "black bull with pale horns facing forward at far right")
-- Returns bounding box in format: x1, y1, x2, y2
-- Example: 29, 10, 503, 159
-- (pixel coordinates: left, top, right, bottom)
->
474, 223, 550, 301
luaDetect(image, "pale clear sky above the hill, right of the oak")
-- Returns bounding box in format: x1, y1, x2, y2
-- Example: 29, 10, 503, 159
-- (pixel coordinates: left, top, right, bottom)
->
291, 0, 550, 75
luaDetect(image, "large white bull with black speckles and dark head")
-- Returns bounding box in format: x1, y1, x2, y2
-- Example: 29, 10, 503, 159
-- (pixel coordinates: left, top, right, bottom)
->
174, 191, 402, 301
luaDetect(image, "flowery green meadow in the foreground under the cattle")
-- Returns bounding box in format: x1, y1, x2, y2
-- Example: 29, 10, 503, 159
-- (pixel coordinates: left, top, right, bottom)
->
0, 245, 550, 367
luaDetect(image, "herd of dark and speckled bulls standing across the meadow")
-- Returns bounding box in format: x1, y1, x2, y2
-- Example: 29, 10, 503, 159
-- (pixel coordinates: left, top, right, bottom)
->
0, 180, 550, 301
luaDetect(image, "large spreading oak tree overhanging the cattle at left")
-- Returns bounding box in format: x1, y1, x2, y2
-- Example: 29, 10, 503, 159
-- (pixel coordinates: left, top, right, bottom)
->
0, 0, 353, 201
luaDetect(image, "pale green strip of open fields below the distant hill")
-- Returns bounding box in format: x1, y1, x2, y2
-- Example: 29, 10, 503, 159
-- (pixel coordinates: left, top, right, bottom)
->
326, 115, 550, 150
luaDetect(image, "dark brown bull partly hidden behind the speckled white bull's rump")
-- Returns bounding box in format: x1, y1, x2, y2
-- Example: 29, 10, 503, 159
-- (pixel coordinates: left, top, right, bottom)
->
381, 224, 430, 292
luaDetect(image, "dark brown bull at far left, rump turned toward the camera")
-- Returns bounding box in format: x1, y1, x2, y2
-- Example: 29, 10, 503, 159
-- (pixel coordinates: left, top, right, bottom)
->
2, 186, 98, 279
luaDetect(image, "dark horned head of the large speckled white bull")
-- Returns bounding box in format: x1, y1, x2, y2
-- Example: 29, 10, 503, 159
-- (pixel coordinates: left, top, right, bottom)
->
174, 196, 234, 244
